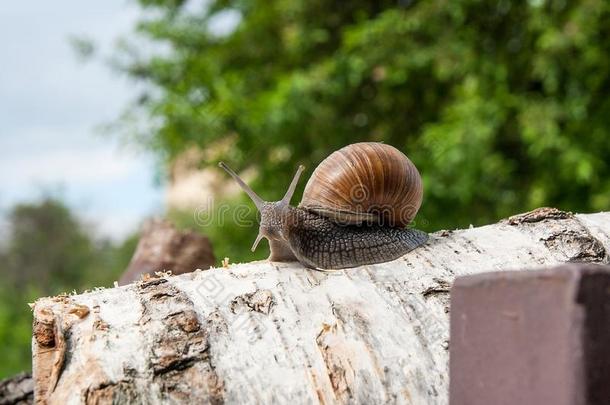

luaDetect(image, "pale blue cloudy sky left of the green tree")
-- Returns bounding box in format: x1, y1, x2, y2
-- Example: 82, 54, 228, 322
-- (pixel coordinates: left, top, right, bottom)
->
0, 0, 164, 240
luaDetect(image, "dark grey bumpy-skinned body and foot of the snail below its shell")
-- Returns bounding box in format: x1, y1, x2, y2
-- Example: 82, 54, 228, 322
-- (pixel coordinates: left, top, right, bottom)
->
285, 207, 428, 269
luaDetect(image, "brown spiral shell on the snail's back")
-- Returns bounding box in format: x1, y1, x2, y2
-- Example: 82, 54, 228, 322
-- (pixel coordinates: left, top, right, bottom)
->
299, 142, 423, 227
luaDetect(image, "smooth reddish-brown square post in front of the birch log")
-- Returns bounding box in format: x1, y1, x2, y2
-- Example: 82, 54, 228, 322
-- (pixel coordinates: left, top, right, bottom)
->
449, 264, 610, 405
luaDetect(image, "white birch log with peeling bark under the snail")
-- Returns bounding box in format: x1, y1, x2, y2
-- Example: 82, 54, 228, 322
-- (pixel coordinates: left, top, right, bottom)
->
33, 208, 610, 404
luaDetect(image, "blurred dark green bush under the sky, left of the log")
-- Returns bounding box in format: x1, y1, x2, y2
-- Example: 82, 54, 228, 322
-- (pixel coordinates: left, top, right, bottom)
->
0, 198, 137, 379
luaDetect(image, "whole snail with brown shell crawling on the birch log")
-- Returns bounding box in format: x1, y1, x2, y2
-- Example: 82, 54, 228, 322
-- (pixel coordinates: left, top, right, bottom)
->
219, 142, 428, 270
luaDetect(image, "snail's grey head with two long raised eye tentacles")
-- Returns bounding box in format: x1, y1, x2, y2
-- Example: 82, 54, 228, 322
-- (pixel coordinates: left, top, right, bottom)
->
218, 162, 305, 252
